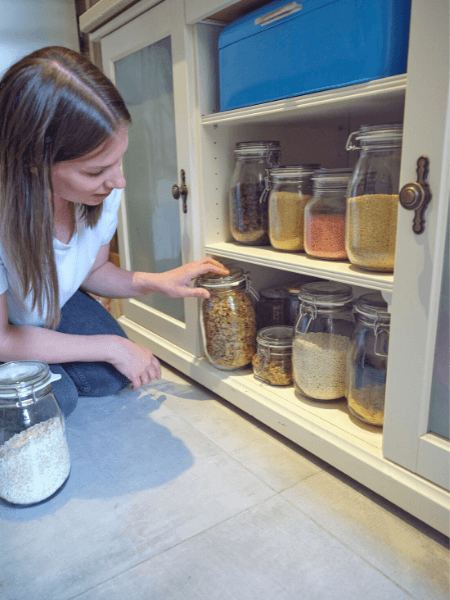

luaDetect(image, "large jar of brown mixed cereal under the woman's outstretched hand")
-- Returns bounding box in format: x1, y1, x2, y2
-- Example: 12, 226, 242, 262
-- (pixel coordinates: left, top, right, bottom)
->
197, 267, 258, 370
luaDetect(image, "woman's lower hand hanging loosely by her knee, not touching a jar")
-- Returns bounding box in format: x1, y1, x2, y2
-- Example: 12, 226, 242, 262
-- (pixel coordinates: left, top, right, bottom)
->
107, 336, 161, 390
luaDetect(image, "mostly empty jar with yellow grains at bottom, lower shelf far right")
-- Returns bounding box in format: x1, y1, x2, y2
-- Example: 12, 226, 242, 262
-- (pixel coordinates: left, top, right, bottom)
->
345, 292, 390, 425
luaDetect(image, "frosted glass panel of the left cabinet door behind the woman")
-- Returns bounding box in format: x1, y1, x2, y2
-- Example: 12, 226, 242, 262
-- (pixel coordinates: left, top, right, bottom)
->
115, 37, 184, 322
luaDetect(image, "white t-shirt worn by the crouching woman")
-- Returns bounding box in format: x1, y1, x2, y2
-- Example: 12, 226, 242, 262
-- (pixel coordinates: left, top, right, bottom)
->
0, 190, 122, 326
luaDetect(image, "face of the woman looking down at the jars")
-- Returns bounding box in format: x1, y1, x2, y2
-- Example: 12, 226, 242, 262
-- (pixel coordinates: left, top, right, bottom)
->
52, 125, 128, 206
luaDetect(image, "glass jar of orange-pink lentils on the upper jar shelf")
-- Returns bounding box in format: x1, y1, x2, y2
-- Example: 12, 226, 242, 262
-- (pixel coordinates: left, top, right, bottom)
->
305, 169, 352, 260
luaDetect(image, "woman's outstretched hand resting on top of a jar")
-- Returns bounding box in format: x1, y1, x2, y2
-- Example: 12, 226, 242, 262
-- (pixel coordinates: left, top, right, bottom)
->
151, 257, 229, 298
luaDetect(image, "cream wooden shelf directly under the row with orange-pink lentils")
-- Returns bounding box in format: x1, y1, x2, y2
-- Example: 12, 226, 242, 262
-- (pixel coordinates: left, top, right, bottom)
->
205, 242, 394, 293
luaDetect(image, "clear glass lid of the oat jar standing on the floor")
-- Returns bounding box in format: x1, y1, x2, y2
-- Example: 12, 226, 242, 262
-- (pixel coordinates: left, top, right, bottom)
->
0, 360, 57, 401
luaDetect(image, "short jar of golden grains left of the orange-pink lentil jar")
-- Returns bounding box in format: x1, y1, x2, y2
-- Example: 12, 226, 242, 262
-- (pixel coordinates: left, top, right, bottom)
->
266, 165, 320, 252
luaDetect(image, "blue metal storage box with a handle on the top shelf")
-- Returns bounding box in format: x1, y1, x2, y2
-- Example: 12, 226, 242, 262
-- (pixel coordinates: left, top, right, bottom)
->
219, 0, 411, 110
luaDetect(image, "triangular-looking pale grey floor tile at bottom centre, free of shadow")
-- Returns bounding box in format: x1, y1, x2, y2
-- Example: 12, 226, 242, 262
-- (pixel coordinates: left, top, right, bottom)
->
72, 496, 410, 600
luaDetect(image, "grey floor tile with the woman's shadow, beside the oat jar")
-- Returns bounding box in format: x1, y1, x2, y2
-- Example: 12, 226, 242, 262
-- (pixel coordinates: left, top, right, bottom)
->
0, 390, 274, 600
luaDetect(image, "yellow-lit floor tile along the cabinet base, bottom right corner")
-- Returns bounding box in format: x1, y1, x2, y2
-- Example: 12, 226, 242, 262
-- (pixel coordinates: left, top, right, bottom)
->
282, 469, 450, 600
